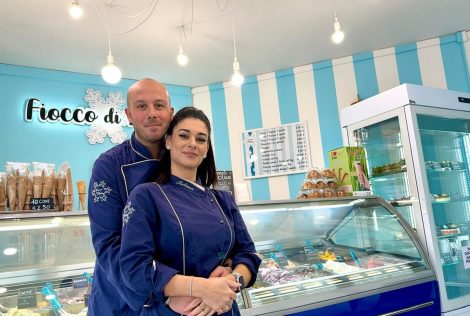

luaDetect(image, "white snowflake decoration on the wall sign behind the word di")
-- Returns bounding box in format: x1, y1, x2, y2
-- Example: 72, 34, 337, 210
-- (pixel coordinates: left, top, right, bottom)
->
84, 89, 129, 144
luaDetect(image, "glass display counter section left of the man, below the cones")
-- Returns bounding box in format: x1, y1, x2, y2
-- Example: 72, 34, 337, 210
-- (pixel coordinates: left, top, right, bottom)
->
0, 211, 95, 316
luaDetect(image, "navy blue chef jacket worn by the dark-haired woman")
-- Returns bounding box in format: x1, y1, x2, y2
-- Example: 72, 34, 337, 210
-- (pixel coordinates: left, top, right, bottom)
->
120, 176, 261, 316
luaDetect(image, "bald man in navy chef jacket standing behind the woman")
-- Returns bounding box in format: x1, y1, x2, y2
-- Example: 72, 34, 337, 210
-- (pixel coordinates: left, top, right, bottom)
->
88, 78, 173, 316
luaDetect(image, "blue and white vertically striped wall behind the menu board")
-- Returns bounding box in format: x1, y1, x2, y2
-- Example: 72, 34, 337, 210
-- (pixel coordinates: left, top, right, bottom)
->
192, 32, 470, 201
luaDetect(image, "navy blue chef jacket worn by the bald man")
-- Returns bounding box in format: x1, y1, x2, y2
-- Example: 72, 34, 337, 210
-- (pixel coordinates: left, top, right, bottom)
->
88, 133, 159, 316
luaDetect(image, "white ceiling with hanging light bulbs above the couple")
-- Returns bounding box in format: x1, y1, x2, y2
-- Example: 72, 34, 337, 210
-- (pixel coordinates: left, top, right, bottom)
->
0, 0, 470, 87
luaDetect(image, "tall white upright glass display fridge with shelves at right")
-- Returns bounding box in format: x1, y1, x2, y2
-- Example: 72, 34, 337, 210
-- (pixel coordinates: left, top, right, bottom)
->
341, 84, 470, 314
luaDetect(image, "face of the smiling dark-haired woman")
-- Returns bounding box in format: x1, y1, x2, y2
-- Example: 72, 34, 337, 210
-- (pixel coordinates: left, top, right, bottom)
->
166, 118, 209, 174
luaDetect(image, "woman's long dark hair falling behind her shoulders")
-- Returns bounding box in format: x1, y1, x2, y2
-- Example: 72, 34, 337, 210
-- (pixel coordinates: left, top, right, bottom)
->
157, 106, 217, 187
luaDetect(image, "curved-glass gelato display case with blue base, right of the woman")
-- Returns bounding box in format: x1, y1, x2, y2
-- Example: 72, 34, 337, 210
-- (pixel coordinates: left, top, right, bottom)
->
240, 197, 440, 315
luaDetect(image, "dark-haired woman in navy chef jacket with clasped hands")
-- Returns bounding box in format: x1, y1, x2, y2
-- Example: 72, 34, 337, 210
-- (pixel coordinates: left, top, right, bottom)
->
120, 107, 261, 316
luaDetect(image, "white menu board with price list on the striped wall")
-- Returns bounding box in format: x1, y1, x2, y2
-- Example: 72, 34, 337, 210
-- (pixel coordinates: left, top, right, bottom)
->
242, 122, 310, 179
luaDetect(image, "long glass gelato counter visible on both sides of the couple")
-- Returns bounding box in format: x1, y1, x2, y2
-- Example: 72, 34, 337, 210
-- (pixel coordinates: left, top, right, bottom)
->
0, 197, 440, 316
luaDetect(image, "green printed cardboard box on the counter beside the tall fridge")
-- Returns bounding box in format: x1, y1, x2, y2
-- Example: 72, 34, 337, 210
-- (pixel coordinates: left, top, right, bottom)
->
328, 147, 370, 195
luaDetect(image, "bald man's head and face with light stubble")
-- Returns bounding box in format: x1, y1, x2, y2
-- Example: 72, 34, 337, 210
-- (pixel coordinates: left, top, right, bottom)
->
126, 80, 173, 146
